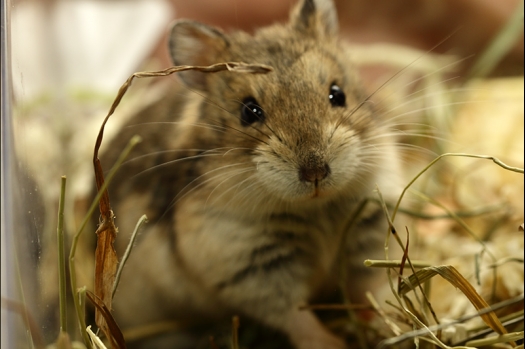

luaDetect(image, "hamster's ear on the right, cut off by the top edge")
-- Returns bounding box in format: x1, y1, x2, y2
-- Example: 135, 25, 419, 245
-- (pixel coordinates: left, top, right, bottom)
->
290, 0, 339, 39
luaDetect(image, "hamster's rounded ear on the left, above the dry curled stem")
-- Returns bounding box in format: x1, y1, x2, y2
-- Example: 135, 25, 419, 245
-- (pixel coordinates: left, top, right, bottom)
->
169, 20, 229, 90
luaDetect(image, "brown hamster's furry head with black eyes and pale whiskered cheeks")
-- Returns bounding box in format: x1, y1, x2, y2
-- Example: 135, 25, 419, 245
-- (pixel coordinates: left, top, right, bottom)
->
170, 0, 398, 202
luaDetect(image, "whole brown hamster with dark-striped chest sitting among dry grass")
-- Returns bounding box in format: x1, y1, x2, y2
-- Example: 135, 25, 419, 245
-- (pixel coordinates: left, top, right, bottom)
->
102, 0, 400, 349
